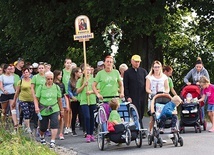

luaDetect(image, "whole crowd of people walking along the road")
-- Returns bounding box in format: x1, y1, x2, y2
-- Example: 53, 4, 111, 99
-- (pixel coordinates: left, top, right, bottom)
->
0, 55, 214, 147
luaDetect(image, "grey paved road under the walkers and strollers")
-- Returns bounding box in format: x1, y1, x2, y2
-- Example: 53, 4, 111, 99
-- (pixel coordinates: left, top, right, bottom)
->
40, 118, 214, 155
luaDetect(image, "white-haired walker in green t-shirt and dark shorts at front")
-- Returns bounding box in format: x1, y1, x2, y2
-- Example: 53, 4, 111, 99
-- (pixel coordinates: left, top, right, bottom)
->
35, 71, 64, 148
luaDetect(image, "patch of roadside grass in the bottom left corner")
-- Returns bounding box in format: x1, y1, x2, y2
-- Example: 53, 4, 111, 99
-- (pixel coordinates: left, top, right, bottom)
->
0, 117, 57, 155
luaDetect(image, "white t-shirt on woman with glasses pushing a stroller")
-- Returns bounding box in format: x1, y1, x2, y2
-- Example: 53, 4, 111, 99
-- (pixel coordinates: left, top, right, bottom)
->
146, 74, 168, 94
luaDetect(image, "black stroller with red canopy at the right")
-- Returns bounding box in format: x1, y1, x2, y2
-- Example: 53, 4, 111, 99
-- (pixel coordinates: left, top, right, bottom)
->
179, 85, 207, 133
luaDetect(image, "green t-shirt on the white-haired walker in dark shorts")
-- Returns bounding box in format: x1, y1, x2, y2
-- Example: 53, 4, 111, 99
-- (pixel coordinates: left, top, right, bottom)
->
36, 84, 62, 116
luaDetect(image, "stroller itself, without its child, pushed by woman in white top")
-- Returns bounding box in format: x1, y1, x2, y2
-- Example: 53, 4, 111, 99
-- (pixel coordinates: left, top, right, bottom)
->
148, 94, 183, 148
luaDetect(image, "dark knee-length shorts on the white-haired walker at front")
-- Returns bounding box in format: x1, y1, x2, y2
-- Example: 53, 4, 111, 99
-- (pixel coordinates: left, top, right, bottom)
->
39, 112, 59, 132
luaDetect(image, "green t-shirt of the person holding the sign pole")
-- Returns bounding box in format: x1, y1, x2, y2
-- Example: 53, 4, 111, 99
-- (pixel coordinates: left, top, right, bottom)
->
76, 76, 96, 105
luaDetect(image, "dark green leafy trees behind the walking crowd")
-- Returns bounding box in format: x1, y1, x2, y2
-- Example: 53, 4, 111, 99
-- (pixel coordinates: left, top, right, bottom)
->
0, 0, 213, 89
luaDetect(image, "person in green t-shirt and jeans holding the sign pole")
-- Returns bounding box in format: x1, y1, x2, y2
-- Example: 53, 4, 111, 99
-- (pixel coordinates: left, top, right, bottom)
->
76, 65, 96, 143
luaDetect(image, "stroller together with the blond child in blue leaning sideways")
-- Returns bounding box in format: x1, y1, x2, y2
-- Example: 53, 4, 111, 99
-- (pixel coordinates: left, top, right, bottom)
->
148, 94, 183, 147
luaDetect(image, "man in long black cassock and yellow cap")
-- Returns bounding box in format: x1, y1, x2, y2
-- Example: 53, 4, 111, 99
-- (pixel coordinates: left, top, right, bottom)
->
123, 55, 148, 132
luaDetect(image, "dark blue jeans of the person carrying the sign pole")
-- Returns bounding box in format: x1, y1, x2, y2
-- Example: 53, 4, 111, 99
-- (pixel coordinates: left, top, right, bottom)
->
81, 105, 96, 135
